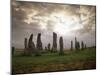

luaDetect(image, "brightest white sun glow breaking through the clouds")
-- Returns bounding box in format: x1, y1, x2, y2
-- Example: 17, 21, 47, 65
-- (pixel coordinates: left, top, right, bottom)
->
52, 13, 72, 35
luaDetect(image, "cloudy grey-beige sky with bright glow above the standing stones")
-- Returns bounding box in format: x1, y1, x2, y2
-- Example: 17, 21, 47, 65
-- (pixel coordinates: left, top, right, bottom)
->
11, 0, 96, 49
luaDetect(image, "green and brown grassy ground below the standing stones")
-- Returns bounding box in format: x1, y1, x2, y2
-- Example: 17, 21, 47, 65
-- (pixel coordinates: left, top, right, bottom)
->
12, 48, 96, 74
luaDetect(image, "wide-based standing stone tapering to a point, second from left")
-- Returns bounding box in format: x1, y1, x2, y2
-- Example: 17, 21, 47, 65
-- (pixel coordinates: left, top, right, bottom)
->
28, 34, 35, 54
